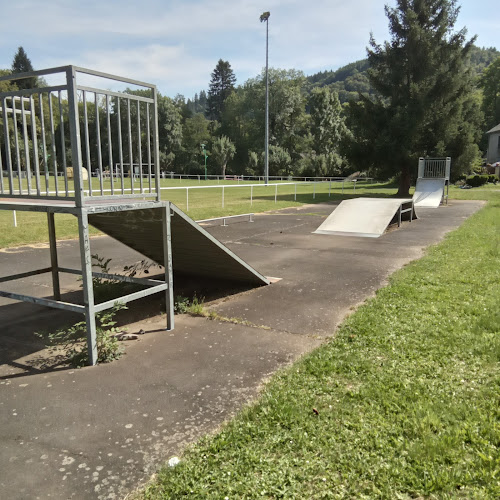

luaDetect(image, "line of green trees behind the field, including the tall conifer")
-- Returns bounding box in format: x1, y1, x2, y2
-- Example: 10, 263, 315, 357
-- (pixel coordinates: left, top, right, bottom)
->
2, 0, 500, 195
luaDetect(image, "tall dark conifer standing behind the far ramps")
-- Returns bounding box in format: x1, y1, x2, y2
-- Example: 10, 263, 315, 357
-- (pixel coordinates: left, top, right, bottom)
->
350, 0, 479, 193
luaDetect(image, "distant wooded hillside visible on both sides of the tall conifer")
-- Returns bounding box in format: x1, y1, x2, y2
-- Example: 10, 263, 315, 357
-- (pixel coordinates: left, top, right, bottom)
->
306, 46, 500, 103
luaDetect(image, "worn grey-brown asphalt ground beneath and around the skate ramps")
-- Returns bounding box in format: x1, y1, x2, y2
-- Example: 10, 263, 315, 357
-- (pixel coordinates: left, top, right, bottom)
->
0, 197, 483, 499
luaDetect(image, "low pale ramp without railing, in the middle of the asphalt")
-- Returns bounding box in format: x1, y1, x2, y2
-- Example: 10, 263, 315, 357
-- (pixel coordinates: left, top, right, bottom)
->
314, 198, 416, 238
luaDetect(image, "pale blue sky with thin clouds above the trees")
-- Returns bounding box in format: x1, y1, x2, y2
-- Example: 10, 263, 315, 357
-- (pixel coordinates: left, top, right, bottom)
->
0, 0, 500, 98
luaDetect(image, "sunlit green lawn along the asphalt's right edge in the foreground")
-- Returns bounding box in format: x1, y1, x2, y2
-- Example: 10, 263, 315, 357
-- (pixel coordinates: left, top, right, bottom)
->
143, 198, 500, 499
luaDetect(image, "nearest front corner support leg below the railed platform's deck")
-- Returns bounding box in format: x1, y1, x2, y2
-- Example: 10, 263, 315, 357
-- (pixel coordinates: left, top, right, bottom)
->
78, 210, 97, 365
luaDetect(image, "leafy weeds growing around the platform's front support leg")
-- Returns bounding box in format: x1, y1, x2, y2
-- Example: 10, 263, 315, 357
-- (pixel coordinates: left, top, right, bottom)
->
35, 302, 127, 367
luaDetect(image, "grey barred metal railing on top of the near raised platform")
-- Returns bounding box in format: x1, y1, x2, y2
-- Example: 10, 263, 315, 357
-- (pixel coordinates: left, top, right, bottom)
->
0, 66, 160, 206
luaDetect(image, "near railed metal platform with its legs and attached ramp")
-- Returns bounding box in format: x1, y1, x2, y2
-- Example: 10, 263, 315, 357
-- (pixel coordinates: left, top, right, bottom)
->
0, 66, 269, 364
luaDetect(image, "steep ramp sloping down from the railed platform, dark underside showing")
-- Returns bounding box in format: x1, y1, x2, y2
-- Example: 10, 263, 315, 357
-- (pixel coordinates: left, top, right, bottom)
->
89, 204, 269, 286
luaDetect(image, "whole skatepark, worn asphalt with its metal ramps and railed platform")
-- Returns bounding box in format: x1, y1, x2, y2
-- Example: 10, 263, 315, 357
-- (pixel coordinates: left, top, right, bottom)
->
0, 67, 490, 498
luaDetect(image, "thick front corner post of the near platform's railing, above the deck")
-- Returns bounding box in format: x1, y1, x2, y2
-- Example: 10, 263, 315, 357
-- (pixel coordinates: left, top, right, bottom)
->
65, 66, 85, 207
